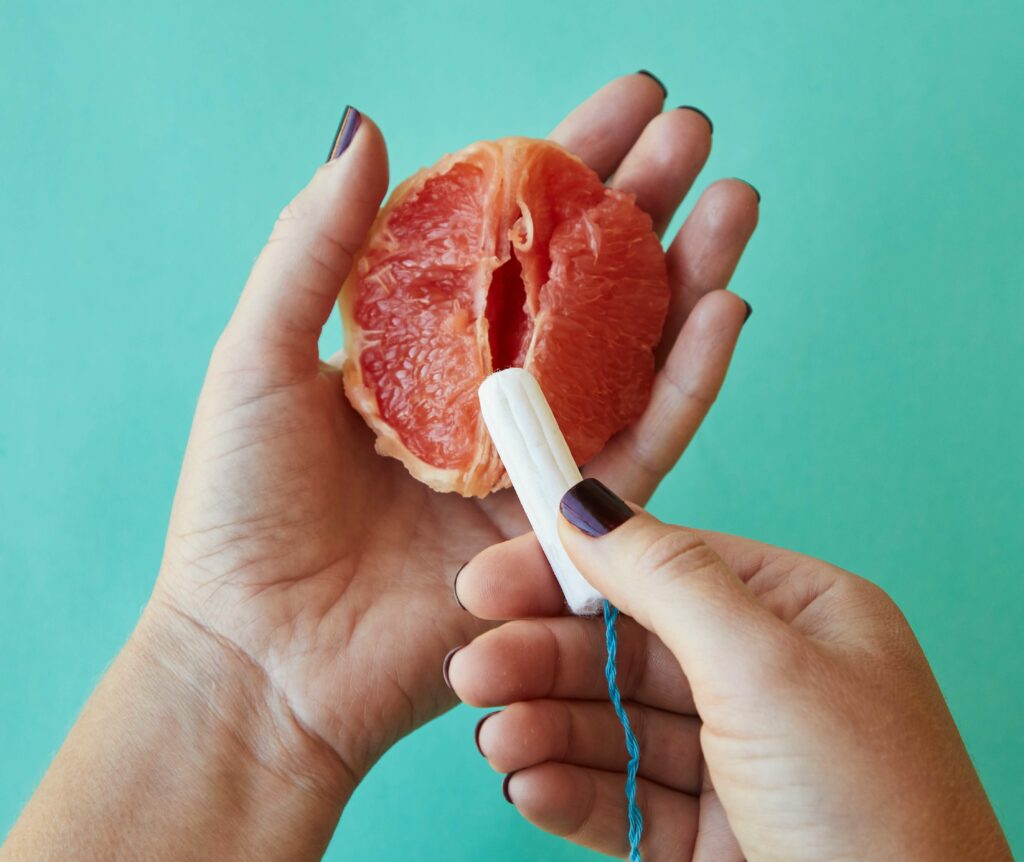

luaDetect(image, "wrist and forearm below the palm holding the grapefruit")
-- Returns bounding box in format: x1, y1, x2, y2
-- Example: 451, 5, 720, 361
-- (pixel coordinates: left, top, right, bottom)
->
3, 601, 355, 862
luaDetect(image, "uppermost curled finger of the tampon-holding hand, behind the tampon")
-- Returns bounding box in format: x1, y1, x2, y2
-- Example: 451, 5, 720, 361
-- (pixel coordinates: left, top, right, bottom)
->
455, 532, 567, 619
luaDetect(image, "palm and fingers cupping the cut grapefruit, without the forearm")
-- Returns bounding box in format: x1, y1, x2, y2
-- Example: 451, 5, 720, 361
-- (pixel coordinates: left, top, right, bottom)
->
148, 75, 758, 792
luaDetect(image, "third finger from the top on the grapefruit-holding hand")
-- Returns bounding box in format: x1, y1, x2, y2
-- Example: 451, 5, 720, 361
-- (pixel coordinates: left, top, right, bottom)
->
658, 179, 760, 361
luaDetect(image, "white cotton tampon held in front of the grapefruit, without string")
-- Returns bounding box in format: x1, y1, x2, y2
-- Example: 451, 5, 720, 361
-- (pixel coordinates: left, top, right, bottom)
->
479, 369, 603, 614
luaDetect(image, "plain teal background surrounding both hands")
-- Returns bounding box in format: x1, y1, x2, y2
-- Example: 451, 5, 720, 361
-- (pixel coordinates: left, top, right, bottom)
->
0, 0, 1024, 860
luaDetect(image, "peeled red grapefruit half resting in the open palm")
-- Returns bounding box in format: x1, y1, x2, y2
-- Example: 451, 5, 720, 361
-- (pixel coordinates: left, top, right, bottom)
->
340, 138, 669, 497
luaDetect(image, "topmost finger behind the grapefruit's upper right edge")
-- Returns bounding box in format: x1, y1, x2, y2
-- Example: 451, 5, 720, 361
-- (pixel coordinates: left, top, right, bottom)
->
549, 73, 665, 179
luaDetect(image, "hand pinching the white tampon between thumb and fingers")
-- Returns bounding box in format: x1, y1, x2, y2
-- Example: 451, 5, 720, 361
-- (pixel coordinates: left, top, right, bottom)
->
450, 480, 1011, 862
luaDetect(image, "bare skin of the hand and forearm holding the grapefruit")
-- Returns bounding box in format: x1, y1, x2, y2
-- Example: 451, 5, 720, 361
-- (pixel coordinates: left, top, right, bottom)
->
0, 75, 758, 860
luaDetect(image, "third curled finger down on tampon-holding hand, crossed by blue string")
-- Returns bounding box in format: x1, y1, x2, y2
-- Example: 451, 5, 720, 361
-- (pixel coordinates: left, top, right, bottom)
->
476, 700, 701, 794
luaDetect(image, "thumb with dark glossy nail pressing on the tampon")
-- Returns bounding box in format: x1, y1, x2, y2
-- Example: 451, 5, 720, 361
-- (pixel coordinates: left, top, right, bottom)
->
558, 478, 793, 694
